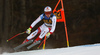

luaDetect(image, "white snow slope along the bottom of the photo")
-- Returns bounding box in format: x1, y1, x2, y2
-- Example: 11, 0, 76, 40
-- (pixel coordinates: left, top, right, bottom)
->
1, 44, 100, 55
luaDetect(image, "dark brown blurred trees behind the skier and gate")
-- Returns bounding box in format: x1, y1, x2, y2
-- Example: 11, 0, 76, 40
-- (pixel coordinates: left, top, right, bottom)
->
0, 0, 100, 52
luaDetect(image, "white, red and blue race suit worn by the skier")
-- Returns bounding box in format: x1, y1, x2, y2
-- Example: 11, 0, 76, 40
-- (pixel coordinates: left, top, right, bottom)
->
27, 14, 56, 40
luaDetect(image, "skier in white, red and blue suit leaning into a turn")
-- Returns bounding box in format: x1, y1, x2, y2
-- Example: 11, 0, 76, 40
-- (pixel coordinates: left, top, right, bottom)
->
23, 6, 56, 43
